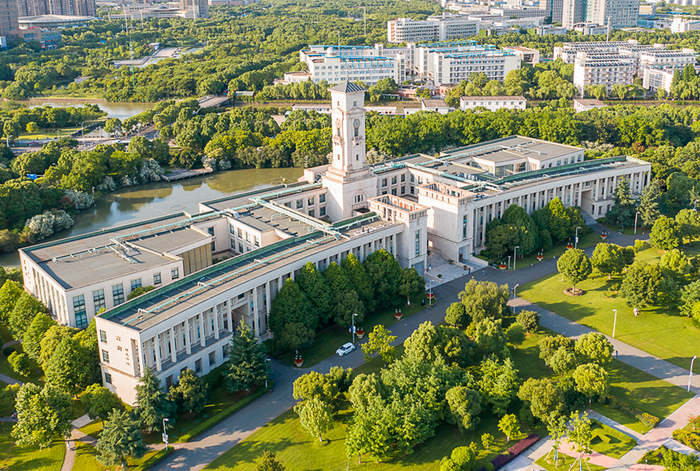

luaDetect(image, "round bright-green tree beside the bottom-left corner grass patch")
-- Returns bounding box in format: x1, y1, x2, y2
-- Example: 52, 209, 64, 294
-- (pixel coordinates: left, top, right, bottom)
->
12, 383, 73, 449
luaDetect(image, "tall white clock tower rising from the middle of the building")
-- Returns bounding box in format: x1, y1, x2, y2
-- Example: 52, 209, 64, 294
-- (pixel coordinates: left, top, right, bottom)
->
323, 82, 377, 222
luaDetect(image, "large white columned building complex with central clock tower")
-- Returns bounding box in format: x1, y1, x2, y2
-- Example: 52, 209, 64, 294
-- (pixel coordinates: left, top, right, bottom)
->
20, 82, 651, 404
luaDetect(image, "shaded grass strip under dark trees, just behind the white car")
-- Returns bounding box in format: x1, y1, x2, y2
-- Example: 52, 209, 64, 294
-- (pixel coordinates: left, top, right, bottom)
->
267, 293, 426, 368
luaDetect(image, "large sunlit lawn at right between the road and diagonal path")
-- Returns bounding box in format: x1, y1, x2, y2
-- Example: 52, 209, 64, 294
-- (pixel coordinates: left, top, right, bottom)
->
518, 249, 700, 373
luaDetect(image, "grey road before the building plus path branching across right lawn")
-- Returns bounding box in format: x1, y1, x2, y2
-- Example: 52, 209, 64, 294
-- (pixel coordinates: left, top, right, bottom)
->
151, 224, 700, 471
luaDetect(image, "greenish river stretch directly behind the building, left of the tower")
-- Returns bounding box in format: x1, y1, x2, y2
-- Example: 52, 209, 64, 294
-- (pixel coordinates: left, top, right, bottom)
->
0, 168, 304, 267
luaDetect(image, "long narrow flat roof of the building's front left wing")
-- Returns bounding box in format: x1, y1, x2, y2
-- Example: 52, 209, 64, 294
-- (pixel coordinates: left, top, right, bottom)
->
100, 213, 399, 331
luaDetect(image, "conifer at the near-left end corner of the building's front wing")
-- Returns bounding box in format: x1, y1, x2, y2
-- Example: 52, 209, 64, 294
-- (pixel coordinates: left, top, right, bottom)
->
136, 367, 176, 431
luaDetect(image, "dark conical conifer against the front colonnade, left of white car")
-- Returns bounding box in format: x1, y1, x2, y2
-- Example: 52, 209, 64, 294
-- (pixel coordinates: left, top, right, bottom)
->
225, 320, 270, 394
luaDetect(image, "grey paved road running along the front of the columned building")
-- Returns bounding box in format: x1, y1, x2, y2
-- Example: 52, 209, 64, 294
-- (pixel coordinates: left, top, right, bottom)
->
152, 224, 660, 471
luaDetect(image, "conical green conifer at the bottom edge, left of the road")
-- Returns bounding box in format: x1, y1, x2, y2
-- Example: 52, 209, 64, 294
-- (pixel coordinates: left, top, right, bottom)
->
95, 410, 147, 469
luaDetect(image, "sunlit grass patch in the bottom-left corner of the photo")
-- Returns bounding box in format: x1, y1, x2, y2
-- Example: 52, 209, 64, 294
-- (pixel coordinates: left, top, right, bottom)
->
0, 430, 65, 471
